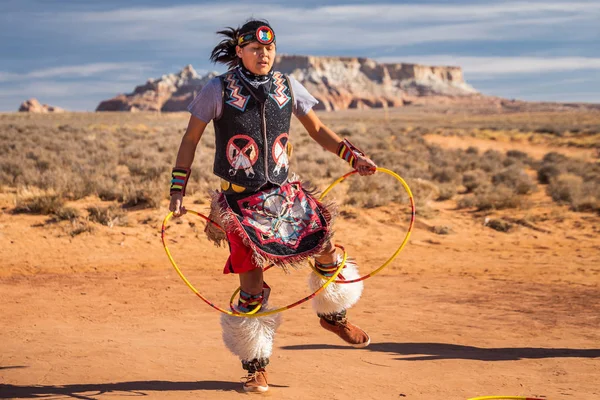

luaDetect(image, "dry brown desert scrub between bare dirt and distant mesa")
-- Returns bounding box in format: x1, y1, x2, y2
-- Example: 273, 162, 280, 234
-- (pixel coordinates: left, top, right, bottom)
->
0, 110, 600, 236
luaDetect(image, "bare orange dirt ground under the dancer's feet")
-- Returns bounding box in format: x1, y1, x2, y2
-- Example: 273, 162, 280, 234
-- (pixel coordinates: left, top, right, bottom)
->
0, 126, 600, 400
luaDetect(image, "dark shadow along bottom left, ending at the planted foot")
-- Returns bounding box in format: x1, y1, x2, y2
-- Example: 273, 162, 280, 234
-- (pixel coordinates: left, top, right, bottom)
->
0, 381, 287, 400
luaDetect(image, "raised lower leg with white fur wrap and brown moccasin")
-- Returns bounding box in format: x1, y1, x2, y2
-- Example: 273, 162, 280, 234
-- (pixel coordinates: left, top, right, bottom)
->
309, 242, 371, 348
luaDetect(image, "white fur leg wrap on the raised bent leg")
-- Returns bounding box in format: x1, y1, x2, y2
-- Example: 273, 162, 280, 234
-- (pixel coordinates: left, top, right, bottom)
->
308, 259, 363, 314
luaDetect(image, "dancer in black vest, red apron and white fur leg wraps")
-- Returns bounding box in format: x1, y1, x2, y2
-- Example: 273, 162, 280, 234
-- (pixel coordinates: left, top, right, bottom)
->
170, 19, 377, 392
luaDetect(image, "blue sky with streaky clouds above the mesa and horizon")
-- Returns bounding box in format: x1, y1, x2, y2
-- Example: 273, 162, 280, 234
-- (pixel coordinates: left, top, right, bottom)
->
0, 0, 600, 111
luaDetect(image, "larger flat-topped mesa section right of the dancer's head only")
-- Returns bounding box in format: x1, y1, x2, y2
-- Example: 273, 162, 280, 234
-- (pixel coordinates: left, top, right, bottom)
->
275, 55, 477, 111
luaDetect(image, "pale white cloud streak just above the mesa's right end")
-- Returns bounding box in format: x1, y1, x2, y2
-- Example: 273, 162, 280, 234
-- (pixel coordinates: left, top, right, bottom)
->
377, 54, 600, 78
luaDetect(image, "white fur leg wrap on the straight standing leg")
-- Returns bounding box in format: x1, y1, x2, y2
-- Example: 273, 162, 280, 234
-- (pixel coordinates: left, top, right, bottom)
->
221, 306, 281, 361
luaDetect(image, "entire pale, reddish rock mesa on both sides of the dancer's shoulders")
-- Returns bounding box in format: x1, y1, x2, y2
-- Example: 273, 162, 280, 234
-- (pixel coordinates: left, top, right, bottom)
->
96, 55, 478, 111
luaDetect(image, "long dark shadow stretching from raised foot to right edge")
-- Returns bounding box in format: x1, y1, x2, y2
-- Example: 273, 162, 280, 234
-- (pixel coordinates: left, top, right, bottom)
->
281, 343, 600, 361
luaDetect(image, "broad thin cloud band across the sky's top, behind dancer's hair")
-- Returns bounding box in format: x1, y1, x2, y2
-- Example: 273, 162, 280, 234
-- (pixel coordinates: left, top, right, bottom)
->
32, 1, 600, 51
